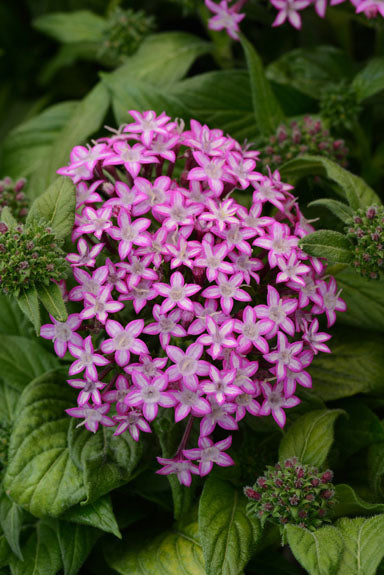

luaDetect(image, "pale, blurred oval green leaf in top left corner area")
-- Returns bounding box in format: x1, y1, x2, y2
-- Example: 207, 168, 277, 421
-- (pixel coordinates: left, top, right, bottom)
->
33, 10, 107, 43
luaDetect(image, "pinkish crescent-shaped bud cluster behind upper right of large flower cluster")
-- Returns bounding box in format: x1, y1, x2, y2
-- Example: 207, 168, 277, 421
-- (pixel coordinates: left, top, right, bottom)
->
260, 116, 348, 168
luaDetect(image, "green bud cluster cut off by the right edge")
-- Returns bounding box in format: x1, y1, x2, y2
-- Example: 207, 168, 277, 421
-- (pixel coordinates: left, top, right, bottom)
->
346, 206, 384, 279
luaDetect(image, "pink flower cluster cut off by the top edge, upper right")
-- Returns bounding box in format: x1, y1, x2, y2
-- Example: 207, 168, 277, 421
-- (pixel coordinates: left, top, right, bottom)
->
205, 0, 384, 40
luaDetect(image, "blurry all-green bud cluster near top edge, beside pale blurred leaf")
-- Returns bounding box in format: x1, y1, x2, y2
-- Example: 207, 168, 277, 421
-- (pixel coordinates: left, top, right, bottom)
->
101, 7, 154, 61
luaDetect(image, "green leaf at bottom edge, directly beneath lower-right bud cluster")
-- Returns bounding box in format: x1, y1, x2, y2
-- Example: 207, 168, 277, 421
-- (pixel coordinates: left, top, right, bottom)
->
285, 525, 344, 575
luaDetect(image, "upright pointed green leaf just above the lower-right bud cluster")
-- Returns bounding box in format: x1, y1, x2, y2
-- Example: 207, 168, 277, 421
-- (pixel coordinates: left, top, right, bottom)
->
279, 409, 345, 467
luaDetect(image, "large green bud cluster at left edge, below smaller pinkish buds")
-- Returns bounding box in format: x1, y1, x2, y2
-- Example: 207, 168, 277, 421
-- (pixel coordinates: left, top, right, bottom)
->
0, 218, 67, 296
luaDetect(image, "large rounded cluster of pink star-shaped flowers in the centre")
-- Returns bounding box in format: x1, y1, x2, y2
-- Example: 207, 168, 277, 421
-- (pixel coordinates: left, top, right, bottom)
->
48, 111, 345, 485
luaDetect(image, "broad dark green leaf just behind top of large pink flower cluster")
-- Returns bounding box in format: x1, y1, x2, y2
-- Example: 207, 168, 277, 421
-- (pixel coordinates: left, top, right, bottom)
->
170, 70, 260, 141
